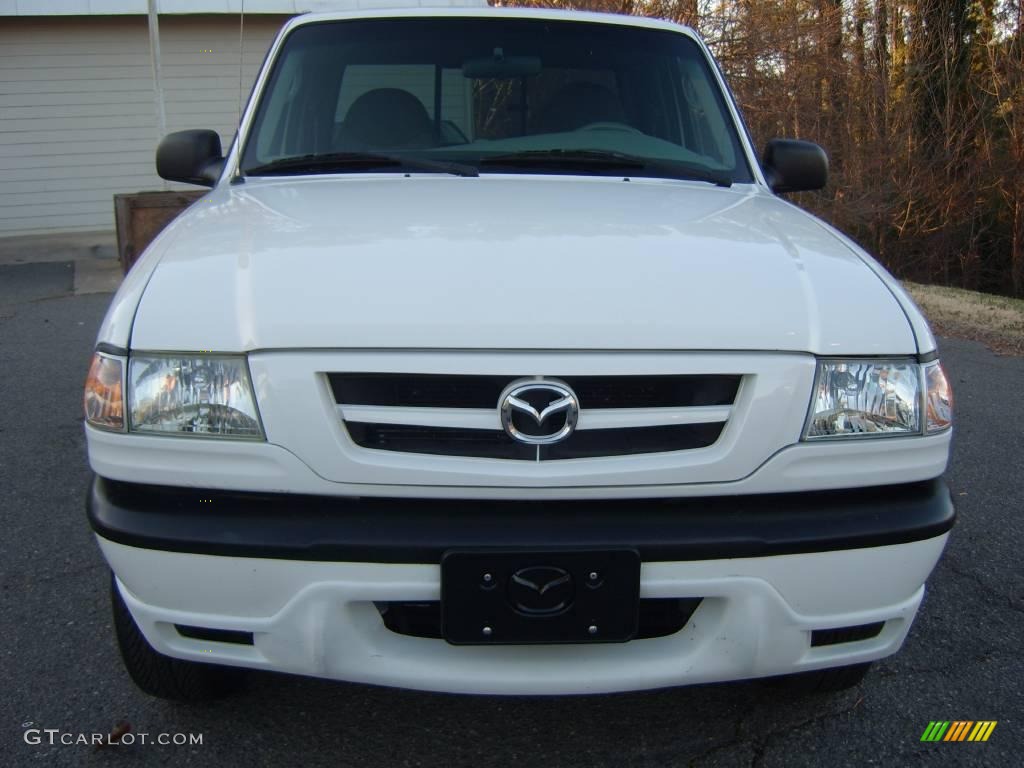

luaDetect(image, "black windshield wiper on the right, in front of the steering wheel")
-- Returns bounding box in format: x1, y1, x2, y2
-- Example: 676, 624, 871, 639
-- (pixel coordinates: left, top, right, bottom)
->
480, 150, 732, 186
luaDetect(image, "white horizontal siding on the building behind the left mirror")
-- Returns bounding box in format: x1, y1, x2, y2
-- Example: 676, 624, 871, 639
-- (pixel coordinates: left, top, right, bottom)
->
0, 14, 285, 237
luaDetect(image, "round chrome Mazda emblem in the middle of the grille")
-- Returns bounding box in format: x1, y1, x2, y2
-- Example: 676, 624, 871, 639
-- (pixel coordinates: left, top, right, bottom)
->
498, 379, 580, 445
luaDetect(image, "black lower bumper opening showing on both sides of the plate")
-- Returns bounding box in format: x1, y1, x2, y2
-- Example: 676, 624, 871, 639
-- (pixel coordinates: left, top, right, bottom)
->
374, 597, 701, 640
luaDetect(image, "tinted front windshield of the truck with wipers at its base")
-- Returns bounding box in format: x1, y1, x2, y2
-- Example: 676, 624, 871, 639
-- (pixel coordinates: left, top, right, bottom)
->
242, 17, 752, 183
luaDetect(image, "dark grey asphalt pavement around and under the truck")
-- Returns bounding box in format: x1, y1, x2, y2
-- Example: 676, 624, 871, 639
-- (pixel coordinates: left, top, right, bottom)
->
0, 265, 1024, 768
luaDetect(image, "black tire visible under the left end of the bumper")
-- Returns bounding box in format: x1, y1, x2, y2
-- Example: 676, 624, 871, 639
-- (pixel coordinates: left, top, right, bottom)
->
111, 573, 245, 701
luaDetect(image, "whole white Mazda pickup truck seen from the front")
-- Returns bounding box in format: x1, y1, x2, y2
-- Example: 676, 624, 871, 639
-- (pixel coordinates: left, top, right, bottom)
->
85, 8, 954, 700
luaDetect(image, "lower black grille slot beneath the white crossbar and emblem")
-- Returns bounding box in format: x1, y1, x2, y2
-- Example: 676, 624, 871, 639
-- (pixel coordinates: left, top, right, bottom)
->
345, 422, 725, 461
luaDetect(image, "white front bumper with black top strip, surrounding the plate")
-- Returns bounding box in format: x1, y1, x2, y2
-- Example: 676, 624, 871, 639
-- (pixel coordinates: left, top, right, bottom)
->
89, 480, 954, 694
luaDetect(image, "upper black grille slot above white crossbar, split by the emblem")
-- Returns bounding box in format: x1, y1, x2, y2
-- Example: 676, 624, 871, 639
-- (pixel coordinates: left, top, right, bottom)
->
328, 373, 742, 409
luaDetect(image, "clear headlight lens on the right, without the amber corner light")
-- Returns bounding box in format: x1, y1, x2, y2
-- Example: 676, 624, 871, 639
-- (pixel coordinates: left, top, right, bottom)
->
805, 359, 922, 439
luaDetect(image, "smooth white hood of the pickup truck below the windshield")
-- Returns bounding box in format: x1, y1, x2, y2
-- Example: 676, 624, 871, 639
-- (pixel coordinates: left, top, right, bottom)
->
131, 174, 916, 354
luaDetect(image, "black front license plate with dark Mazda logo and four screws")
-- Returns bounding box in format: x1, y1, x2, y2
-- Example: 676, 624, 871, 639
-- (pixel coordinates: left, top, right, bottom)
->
441, 549, 640, 645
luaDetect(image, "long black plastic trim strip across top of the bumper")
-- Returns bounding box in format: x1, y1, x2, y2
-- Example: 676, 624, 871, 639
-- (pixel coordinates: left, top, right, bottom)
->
86, 477, 955, 563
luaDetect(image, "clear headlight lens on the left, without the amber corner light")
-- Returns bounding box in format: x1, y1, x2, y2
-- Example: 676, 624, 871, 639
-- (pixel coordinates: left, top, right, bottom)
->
128, 354, 263, 440
